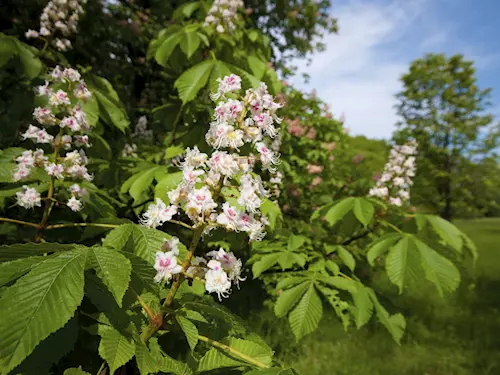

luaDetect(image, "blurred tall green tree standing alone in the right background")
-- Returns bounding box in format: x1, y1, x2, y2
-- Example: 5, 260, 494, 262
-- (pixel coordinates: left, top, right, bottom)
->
395, 54, 497, 219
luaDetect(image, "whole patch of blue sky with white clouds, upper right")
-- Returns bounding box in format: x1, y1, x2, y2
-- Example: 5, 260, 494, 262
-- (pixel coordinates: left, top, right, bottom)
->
294, 0, 500, 138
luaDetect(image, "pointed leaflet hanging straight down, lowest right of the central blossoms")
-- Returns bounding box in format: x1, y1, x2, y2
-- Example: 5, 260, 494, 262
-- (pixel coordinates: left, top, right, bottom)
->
288, 283, 323, 340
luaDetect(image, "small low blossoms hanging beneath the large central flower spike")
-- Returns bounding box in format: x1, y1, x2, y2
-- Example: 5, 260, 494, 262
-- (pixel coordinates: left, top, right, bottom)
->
154, 237, 245, 300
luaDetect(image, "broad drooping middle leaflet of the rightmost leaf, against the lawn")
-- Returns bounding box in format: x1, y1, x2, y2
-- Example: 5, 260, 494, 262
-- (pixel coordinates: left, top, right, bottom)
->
413, 238, 460, 296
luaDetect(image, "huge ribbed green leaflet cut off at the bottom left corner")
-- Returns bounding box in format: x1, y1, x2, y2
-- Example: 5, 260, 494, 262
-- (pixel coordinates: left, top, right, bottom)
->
0, 248, 87, 374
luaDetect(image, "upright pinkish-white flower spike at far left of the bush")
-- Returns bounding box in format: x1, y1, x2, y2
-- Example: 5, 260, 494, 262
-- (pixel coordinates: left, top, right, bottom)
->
12, 66, 93, 211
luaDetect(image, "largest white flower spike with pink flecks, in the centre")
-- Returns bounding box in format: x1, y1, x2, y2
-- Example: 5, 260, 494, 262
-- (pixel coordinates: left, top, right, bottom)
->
141, 75, 281, 241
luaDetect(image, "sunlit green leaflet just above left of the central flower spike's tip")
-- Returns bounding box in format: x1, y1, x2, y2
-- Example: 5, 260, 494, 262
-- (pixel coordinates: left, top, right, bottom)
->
174, 60, 215, 105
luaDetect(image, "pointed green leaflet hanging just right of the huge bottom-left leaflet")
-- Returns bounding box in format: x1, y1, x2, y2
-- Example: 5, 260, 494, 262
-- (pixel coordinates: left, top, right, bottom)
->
90, 247, 132, 307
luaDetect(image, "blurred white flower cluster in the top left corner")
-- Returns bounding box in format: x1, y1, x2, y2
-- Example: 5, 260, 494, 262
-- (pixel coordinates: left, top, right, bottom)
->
25, 0, 87, 51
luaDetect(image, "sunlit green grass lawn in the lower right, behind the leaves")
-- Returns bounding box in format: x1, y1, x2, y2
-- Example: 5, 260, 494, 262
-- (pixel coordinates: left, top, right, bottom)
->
283, 219, 500, 375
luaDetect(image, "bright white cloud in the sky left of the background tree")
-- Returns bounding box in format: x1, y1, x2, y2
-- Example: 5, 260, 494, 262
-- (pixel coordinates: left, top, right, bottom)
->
296, 0, 432, 138
